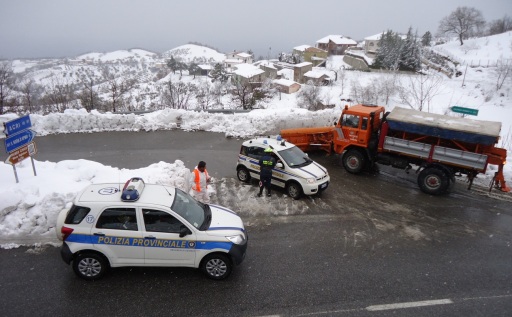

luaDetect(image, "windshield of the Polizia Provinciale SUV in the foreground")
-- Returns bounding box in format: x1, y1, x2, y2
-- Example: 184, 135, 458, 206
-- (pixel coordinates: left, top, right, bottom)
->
171, 188, 211, 229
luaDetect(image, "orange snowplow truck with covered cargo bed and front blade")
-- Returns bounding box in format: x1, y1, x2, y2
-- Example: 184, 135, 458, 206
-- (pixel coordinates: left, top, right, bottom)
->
281, 104, 510, 195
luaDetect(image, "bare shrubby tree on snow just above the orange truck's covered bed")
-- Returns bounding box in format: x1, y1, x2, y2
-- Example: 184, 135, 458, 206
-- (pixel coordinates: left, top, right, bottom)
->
398, 75, 443, 112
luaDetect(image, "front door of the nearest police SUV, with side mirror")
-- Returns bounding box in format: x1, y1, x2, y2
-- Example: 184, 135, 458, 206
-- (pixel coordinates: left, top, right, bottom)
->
142, 208, 196, 266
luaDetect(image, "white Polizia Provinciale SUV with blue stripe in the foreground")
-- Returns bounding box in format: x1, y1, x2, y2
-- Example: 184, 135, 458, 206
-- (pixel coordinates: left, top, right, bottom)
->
56, 178, 247, 280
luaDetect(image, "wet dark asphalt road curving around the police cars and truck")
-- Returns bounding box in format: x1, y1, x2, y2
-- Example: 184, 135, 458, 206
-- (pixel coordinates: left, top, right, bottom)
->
0, 131, 512, 316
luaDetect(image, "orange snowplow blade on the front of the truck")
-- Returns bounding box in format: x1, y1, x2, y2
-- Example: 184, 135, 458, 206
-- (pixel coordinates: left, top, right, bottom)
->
281, 126, 335, 154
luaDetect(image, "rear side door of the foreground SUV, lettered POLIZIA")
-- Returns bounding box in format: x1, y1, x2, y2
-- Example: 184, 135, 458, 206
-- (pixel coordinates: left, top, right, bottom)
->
91, 207, 144, 266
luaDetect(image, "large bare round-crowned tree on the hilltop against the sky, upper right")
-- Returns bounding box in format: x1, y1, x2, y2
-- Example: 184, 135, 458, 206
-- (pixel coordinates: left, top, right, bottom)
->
439, 7, 485, 45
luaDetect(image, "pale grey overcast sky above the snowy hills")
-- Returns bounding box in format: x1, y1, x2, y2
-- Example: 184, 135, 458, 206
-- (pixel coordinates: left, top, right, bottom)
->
0, 0, 512, 59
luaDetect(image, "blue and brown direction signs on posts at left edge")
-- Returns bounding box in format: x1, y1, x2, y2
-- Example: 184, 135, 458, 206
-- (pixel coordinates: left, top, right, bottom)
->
4, 115, 37, 183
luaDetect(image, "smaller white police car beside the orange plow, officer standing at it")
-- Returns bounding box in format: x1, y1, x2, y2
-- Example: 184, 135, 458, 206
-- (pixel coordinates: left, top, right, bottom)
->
236, 136, 330, 199
